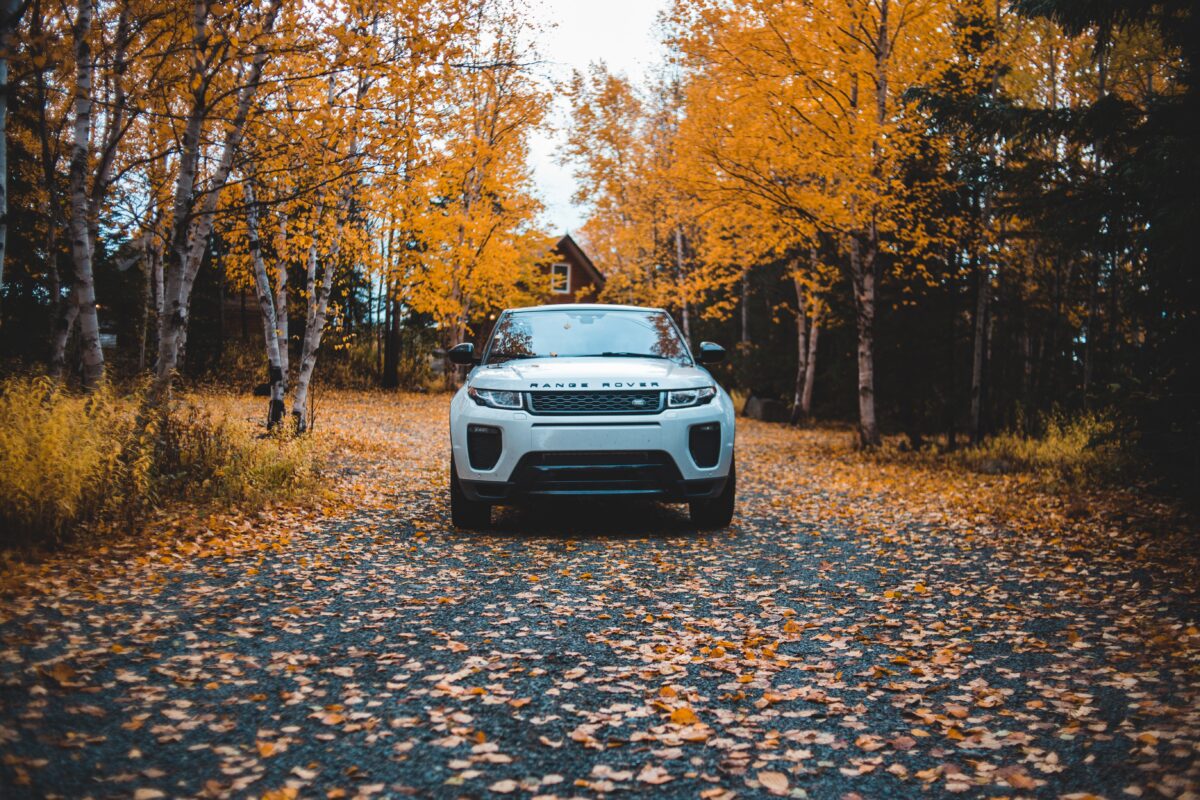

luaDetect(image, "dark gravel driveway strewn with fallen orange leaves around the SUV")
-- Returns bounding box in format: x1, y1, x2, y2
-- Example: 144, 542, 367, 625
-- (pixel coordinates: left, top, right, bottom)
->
0, 395, 1200, 800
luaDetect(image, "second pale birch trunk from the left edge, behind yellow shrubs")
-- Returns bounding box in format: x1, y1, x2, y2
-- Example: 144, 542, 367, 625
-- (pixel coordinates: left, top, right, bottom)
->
71, 0, 104, 390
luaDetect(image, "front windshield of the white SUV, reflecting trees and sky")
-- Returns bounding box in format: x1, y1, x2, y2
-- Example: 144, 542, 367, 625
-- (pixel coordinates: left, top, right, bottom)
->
485, 308, 691, 363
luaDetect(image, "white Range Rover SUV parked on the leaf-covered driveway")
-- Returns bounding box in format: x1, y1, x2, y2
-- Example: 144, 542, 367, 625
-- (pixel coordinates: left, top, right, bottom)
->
450, 305, 737, 528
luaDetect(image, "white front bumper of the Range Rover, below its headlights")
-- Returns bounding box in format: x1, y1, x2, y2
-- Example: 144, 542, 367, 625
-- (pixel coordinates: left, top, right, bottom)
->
450, 392, 734, 504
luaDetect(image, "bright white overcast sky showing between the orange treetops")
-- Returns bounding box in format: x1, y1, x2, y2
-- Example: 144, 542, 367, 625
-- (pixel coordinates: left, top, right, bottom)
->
529, 0, 667, 234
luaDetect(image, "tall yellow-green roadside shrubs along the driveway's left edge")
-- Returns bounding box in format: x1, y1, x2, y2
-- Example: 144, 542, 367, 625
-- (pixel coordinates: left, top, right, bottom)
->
0, 378, 320, 546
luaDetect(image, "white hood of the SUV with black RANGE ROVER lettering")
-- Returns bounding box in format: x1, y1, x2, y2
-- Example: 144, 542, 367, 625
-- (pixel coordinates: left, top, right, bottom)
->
470, 357, 714, 391
